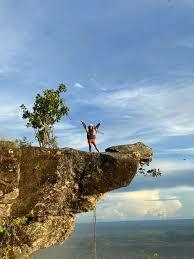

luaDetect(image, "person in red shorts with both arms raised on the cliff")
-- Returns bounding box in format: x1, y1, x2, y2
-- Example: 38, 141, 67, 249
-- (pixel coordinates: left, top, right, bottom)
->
81, 120, 100, 152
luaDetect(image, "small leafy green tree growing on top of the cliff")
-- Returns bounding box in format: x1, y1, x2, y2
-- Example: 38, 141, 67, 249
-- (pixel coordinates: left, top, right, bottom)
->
20, 84, 69, 147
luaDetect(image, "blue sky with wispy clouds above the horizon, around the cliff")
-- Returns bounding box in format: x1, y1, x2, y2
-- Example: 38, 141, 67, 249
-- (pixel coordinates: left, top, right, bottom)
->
0, 0, 194, 220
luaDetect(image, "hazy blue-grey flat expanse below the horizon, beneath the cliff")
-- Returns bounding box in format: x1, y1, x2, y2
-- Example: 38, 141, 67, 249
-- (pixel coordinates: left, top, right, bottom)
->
31, 219, 194, 259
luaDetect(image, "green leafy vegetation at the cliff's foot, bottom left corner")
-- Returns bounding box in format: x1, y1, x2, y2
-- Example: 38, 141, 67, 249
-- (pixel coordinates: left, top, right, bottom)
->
0, 216, 27, 259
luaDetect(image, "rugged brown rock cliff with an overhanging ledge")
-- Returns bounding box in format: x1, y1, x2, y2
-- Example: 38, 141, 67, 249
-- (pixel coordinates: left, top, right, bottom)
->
0, 142, 153, 258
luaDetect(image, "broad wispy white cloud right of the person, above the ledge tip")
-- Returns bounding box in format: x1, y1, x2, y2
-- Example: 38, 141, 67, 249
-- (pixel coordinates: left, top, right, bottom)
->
89, 81, 194, 142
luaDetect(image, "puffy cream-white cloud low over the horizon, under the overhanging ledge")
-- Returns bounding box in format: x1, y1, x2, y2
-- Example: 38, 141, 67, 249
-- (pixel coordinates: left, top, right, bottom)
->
77, 190, 182, 221
